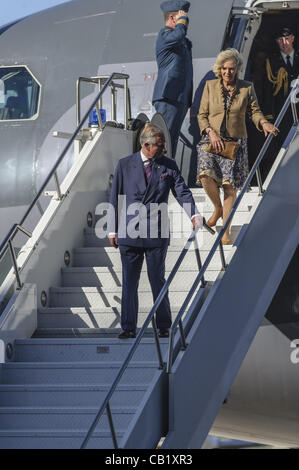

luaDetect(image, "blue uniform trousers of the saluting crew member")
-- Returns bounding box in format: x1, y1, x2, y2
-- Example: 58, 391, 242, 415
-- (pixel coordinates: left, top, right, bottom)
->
154, 100, 188, 158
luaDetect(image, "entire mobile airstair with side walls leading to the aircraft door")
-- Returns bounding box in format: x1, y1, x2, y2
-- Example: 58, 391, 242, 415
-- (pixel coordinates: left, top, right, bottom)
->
0, 74, 299, 449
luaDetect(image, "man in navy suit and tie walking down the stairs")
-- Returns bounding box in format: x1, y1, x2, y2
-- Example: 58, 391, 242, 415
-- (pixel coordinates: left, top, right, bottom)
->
108, 124, 203, 339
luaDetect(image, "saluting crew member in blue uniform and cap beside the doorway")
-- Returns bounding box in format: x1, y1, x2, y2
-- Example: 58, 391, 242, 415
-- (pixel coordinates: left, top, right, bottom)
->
153, 0, 193, 158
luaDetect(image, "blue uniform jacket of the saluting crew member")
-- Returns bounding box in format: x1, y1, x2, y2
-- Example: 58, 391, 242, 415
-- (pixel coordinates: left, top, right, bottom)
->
152, 24, 193, 107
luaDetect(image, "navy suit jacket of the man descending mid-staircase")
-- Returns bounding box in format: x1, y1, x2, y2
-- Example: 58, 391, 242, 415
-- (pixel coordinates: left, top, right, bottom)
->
108, 152, 198, 247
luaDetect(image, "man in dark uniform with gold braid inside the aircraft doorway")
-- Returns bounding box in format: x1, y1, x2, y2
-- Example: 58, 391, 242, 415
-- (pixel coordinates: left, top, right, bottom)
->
260, 26, 299, 179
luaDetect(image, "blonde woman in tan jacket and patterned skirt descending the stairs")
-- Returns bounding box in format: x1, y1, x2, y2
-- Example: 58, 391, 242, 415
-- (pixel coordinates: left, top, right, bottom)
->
197, 49, 278, 245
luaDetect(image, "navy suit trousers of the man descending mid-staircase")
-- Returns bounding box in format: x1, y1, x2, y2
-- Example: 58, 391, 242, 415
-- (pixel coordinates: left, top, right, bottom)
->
119, 244, 171, 332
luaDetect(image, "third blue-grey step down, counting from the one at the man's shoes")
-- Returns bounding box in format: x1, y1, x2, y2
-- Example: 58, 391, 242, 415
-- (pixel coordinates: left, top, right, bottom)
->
0, 384, 147, 407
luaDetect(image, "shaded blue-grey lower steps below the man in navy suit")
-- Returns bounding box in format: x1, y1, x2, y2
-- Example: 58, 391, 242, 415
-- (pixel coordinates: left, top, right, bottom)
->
0, 344, 164, 449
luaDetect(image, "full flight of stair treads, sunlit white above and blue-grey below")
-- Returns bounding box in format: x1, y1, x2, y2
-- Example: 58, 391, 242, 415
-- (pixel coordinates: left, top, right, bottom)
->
0, 189, 258, 448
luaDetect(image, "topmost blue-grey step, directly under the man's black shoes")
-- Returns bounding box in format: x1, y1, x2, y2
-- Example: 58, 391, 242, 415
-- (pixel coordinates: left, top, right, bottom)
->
13, 338, 168, 364
